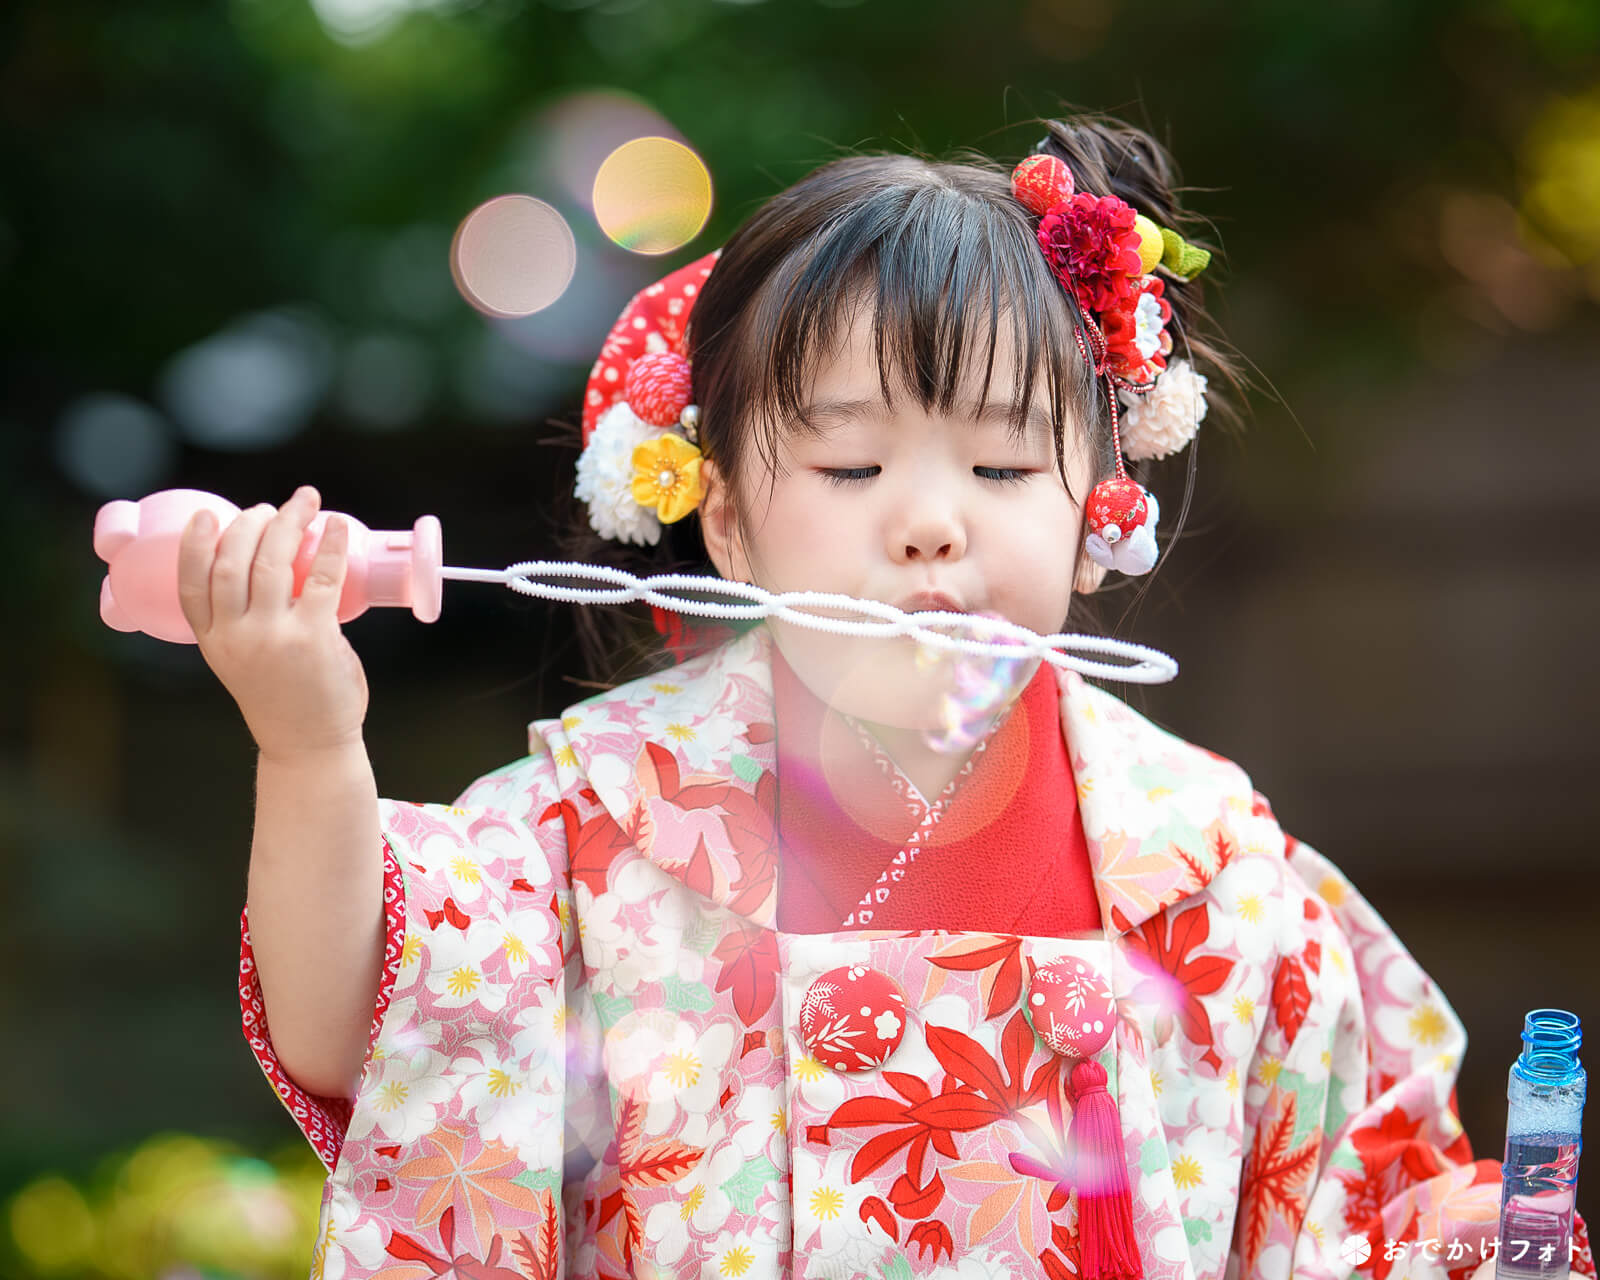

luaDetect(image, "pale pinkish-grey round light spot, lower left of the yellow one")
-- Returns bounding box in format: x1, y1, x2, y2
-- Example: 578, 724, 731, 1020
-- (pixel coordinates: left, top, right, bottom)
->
450, 195, 578, 317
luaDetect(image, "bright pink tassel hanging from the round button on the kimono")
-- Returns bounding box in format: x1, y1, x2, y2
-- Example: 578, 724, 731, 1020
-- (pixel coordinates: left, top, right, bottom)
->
1067, 1059, 1144, 1280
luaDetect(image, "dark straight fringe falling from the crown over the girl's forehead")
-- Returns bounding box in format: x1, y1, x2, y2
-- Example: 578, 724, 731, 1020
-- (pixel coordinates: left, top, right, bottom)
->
696, 157, 1098, 480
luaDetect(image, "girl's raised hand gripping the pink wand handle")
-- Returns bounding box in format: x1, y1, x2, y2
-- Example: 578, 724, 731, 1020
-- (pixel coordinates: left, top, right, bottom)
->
178, 485, 366, 760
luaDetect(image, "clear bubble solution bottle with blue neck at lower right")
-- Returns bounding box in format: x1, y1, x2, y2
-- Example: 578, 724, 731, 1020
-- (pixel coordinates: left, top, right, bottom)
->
1494, 1010, 1589, 1280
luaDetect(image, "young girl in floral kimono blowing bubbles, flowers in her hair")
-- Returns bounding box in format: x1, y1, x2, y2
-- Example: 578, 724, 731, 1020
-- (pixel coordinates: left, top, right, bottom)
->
181, 120, 1594, 1280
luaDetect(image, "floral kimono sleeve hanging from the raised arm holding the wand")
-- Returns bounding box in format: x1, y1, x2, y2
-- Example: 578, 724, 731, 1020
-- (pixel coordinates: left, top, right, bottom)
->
240, 754, 589, 1248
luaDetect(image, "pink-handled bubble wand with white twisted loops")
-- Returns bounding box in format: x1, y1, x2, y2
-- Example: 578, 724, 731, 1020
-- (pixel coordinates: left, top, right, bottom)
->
94, 490, 1178, 685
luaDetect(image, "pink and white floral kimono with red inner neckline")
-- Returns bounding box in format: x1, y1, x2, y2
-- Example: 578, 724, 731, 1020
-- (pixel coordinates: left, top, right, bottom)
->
240, 630, 1594, 1280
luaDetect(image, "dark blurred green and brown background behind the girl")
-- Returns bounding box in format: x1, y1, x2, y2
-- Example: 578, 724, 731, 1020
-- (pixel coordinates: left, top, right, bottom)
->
0, 0, 1600, 1277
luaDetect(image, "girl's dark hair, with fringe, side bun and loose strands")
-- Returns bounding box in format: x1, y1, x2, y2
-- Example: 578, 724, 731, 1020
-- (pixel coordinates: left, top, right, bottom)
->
565, 117, 1240, 682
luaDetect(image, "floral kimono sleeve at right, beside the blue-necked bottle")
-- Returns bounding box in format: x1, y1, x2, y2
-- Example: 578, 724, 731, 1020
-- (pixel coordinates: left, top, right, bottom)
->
1227, 838, 1595, 1280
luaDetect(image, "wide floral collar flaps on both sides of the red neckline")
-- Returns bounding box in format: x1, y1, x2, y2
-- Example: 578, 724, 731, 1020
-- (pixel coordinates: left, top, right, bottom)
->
544, 627, 1251, 934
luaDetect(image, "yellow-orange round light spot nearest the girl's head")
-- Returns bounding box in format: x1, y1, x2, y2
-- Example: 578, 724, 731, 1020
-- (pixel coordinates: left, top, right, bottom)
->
594, 138, 710, 254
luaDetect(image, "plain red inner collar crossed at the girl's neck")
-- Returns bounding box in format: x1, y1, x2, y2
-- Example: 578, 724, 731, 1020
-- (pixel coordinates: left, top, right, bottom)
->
771, 645, 1101, 936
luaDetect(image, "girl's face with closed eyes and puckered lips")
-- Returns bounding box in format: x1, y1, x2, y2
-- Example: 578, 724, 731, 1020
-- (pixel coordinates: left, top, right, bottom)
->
701, 307, 1102, 730
